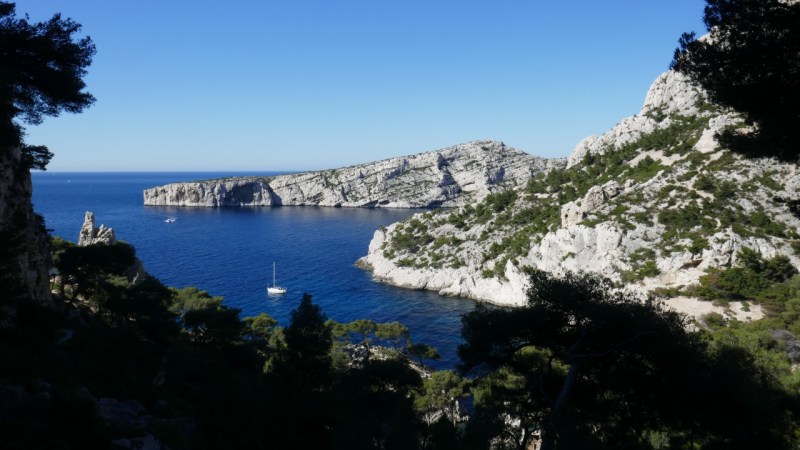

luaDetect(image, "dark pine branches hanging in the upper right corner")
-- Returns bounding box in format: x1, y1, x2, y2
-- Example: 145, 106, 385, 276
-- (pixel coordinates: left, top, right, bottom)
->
672, 0, 800, 161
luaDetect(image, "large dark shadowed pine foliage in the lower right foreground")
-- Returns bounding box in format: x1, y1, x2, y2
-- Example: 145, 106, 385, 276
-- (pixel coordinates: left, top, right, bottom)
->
459, 272, 793, 449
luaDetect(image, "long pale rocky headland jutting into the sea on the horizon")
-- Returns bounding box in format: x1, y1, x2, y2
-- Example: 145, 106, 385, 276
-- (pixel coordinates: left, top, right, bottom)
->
144, 141, 566, 208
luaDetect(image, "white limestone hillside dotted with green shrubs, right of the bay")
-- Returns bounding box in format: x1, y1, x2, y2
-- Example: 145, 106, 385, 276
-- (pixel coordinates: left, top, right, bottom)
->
359, 72, 800, 314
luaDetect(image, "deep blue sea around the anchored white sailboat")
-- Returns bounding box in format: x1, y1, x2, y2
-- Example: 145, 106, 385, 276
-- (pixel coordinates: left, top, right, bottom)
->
32, 172, 474, 369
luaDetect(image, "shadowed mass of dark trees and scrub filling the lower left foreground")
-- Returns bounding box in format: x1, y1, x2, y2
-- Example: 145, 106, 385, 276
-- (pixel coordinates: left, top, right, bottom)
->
0, 239, 482, 449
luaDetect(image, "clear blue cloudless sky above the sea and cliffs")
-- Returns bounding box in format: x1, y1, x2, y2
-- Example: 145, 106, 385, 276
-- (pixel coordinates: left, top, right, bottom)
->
17, 0, 704, 171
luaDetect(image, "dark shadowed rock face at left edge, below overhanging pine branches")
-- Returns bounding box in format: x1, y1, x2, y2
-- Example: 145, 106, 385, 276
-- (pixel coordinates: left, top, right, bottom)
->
0, 147, 50, 304
